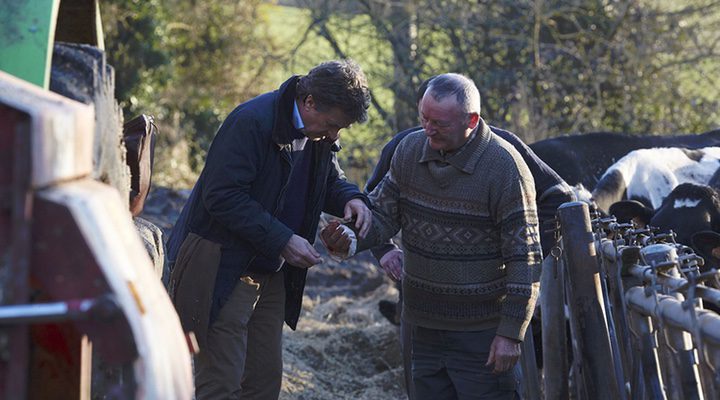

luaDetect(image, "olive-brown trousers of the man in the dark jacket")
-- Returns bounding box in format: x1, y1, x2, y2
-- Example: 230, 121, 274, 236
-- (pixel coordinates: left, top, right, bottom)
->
195, 272, 285, 400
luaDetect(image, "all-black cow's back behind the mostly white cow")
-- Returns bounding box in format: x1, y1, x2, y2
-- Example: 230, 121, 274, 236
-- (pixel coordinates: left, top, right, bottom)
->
530, 129, 720, 190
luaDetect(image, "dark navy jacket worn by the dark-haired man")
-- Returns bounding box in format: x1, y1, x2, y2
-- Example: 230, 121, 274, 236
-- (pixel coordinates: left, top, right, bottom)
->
168, 76, 367, 329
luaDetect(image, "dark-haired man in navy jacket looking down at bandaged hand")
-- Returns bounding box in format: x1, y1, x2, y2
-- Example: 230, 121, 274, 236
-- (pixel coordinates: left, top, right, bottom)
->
169, 61, 371, 399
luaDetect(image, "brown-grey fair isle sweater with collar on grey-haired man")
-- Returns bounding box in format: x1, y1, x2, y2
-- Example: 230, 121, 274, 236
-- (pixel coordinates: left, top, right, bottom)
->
358, 121, 541, 340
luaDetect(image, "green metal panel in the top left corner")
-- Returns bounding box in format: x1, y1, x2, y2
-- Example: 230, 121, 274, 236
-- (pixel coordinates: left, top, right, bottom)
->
0, 0, 60, 89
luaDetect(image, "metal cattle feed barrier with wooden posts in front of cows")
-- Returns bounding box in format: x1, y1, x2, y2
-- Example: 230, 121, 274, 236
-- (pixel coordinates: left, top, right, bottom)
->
536, 202, 720, 399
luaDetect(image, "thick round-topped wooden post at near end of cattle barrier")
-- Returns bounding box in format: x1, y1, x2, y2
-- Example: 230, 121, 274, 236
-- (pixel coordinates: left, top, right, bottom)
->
558, 202, 624, 399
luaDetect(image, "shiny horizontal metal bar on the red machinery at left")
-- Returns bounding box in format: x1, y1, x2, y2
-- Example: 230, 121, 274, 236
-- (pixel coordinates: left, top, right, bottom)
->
0, 295, 120, 326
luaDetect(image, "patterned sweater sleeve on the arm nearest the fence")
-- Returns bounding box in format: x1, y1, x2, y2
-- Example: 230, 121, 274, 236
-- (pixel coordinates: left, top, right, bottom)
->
495, 152, 542, 340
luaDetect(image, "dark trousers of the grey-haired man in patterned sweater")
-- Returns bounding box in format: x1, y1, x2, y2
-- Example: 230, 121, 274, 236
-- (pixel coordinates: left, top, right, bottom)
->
412, 326, 517, 400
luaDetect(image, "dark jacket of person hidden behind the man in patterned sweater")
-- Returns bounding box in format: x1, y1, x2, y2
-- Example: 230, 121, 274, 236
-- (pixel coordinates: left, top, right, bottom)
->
365, 126, 573, 260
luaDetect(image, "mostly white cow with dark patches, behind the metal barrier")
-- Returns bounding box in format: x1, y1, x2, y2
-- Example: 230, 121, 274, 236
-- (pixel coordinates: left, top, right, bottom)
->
592, 147, 720, 212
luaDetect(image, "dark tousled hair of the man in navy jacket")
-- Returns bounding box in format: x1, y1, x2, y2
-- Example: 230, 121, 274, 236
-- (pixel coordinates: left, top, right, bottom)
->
297, 60, 370, 123
